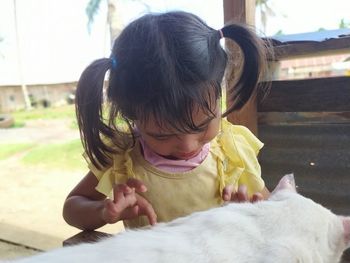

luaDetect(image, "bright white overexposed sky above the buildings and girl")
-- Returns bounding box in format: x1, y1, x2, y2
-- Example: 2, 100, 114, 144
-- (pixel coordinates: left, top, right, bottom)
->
0, 0, 350, 85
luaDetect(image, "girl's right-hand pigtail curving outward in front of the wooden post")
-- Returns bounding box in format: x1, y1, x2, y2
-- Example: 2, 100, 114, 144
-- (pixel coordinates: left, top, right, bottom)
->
219, 24, 267, 116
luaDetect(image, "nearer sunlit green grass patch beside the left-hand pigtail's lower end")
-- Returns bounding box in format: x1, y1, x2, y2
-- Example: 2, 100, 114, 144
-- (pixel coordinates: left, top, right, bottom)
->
22, 139, 86, 170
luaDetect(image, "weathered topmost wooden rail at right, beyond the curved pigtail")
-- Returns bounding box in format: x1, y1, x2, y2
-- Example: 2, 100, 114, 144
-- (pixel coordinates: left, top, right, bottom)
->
274, 37, 350, 60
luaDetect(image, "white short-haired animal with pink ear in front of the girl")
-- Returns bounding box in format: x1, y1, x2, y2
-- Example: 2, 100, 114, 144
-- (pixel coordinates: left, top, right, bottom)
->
7, 175, 350, 263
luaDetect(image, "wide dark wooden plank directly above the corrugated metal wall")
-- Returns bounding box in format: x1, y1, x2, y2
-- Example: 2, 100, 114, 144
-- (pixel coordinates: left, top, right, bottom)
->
258, 77, 350, 112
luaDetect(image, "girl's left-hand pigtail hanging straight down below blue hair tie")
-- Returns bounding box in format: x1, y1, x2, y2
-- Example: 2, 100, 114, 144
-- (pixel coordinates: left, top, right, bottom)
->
75, 58, 113, 168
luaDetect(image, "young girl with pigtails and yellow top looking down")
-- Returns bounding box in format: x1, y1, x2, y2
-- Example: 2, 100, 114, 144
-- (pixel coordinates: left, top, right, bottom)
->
63, 12, 269, 229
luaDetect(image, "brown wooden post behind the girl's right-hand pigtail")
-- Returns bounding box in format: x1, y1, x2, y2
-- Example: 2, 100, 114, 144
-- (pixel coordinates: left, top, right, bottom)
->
223, 0, 258, 135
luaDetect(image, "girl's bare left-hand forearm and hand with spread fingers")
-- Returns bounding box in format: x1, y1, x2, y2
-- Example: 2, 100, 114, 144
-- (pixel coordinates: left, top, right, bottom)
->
63, 171, 157, 230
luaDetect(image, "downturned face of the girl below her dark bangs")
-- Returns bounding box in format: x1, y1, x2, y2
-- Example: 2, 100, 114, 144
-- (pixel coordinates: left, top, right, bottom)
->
135, 103, 221, 160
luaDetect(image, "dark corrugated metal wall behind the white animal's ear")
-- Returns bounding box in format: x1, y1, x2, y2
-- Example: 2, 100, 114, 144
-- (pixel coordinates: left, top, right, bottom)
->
259, 123, 350, 263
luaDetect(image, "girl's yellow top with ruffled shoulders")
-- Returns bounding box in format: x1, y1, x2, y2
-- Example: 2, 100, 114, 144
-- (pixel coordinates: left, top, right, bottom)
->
88, 120, 265, 228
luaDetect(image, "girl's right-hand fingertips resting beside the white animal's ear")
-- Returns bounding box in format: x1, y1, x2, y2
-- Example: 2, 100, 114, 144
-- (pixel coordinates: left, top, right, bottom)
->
222, 185, 264, 203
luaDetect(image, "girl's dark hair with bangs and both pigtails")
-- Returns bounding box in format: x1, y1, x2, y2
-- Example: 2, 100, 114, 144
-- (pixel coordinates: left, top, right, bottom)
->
76, 12, 265, 168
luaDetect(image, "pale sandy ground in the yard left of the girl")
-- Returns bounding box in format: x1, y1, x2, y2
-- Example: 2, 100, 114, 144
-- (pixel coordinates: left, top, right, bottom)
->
0, 120, 121, 260
